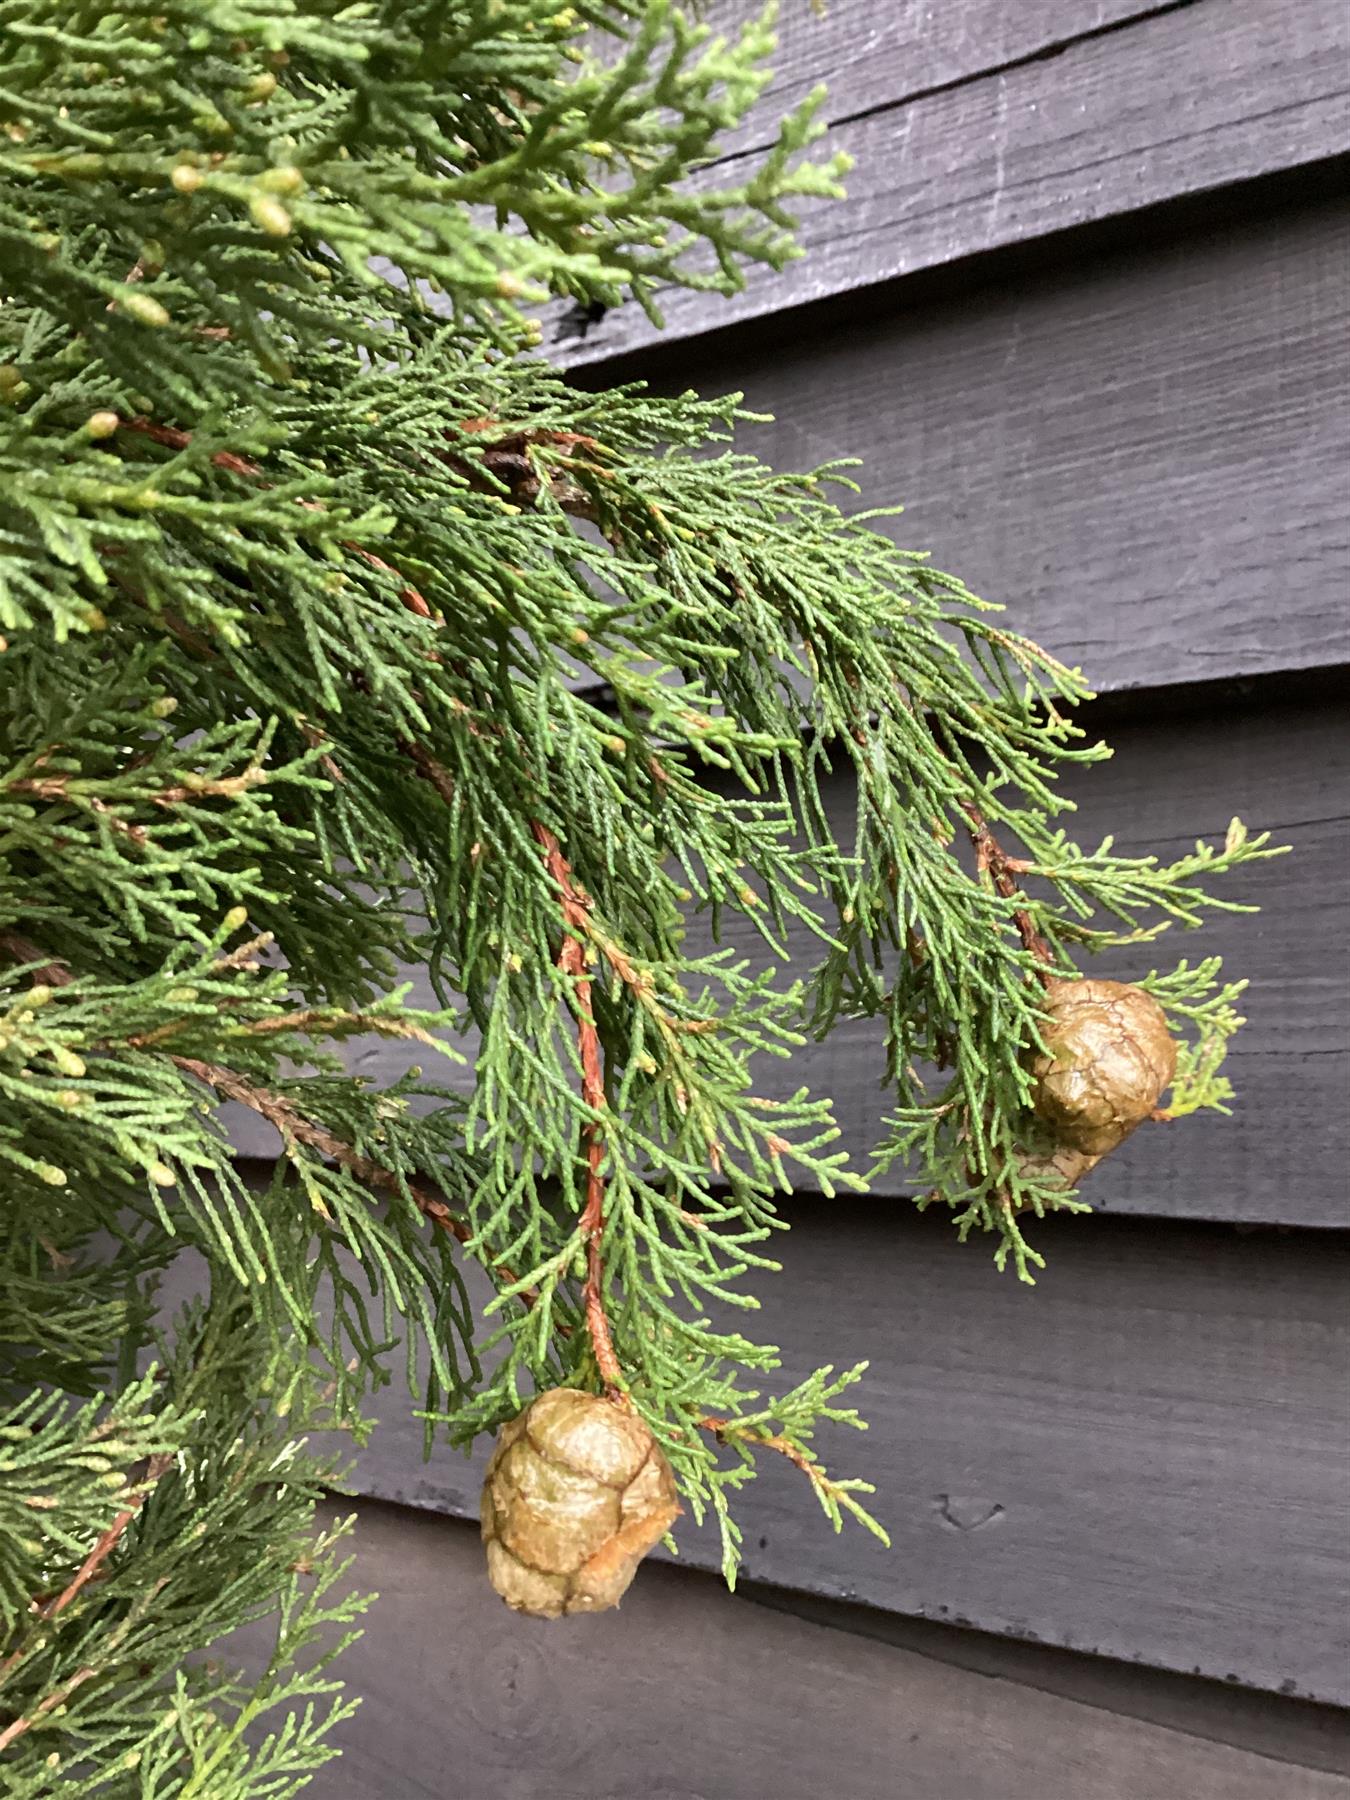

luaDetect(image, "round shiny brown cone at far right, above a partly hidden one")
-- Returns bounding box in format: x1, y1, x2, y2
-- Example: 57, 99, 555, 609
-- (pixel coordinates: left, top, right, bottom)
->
1031, 981, 1177, 1156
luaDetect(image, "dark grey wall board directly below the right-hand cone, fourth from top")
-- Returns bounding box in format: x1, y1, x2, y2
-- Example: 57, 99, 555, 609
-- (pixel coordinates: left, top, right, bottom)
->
338, 1201, 1350, 1699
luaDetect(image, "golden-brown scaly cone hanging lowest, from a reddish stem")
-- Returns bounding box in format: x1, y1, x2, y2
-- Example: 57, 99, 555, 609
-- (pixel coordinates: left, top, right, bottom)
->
482, 1388, 680, 1618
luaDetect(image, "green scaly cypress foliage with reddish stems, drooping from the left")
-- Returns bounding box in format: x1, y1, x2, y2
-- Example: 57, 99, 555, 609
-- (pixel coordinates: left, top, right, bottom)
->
0, 0, 1267, 1800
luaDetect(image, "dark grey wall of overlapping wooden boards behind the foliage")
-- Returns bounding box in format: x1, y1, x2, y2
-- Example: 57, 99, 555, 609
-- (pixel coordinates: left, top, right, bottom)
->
239, 0, 1350, 1800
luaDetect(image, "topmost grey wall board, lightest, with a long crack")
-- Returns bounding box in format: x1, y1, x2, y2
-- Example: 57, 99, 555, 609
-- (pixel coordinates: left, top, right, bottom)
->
551, 0, 1350, 365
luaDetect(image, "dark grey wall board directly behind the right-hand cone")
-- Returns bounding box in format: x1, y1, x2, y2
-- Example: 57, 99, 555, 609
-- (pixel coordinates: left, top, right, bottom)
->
232, 702, 1350, 1226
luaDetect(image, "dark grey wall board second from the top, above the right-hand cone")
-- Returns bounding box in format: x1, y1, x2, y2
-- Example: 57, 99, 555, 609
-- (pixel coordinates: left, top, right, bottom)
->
594, 197, 1350, 691
